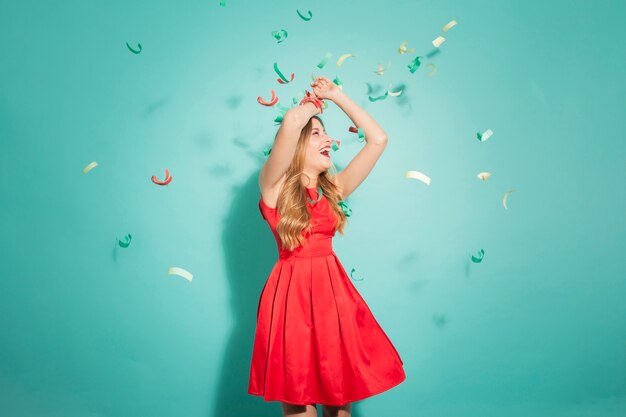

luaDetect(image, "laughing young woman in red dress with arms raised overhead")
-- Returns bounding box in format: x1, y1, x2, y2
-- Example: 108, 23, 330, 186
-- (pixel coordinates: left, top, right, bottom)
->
248, 77, 406, 417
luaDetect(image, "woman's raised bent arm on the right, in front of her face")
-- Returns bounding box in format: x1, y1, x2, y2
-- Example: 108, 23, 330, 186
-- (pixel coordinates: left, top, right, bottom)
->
313, 77, 387, 199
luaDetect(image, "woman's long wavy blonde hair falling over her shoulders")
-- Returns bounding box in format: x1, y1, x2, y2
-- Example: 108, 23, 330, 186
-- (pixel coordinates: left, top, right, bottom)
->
276, 116, 348, 251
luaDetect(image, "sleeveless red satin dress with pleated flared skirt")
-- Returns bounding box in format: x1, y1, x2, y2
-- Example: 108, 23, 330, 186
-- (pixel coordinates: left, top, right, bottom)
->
248, 188, 406, 406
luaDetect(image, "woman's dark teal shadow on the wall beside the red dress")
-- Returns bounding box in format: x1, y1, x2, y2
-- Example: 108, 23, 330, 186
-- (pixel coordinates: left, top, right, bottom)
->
211, 167, 360, 417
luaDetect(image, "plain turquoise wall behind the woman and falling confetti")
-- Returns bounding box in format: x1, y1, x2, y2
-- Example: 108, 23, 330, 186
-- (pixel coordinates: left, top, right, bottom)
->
0, 0, 626, 417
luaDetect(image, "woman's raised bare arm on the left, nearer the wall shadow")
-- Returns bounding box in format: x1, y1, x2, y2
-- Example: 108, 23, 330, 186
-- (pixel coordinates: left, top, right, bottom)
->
259, 103, 319, 194
